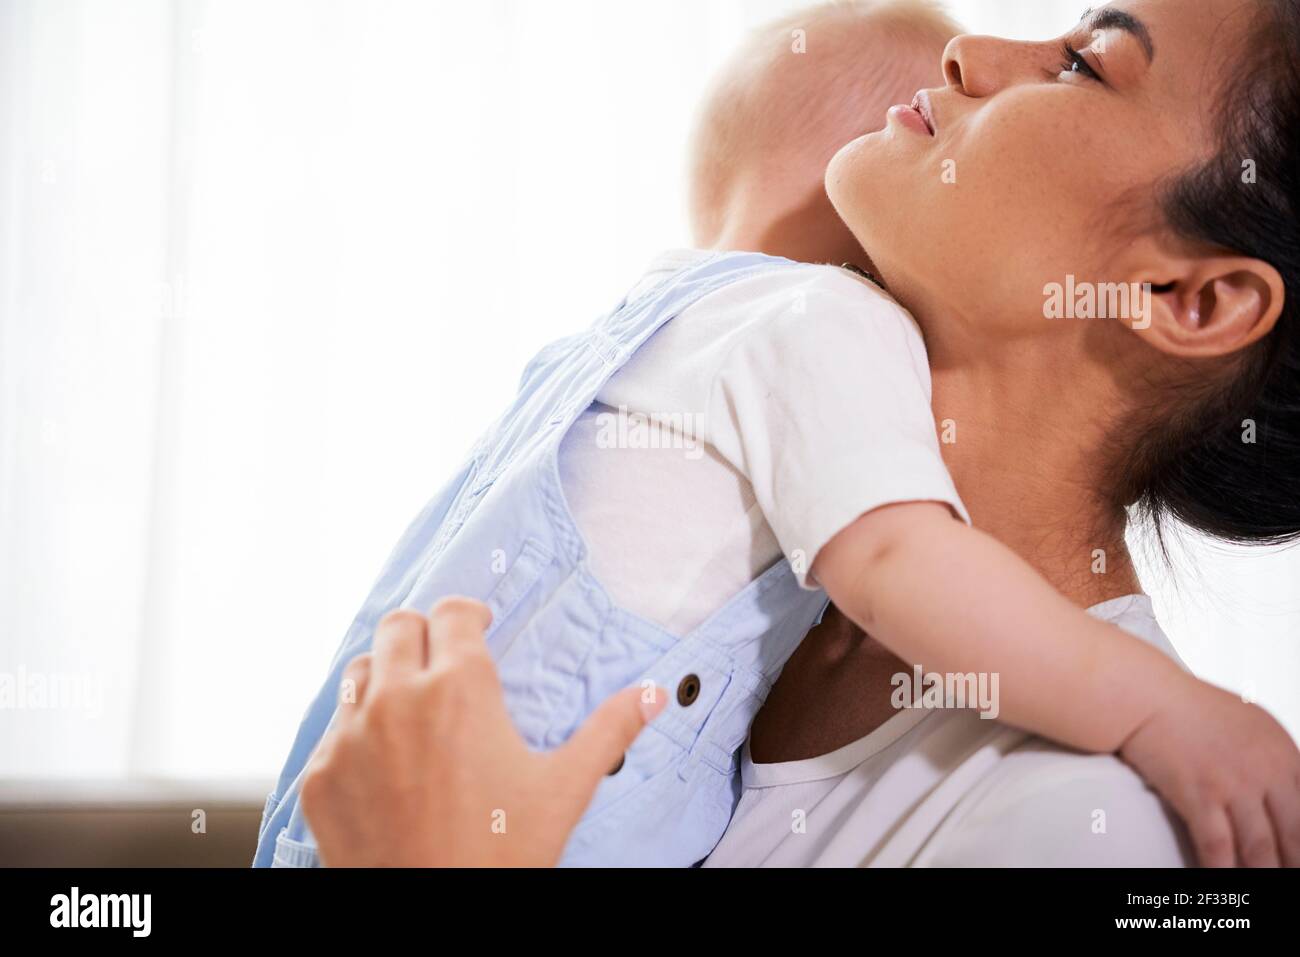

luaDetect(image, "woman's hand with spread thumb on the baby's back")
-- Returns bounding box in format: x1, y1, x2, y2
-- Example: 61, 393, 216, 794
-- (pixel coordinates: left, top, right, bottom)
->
302, 598, 667, 867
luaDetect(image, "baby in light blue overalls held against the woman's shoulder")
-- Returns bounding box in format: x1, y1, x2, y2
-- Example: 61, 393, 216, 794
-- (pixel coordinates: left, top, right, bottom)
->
256, 3, 1294, 866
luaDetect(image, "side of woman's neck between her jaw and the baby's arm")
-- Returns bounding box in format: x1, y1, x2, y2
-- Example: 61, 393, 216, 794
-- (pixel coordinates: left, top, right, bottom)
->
927, 337, 1140, 607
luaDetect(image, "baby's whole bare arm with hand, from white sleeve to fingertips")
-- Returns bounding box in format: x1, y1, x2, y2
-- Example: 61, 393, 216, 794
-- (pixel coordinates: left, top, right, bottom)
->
813, 502, 1300, 865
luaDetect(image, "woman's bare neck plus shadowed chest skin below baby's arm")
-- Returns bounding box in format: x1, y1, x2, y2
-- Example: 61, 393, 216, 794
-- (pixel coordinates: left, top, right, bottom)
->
750, 306, 1139, 763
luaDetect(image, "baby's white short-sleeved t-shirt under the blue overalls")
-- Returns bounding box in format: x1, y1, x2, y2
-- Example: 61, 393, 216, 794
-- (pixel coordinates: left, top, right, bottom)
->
560, 250, 969, 635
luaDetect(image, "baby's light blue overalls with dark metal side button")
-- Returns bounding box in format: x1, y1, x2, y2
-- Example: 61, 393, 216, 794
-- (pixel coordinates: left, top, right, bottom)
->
254, 254, 827, 866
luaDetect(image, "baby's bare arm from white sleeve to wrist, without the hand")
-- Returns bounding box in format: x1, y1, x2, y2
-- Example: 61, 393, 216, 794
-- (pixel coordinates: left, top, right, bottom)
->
813, 502, 1195, 752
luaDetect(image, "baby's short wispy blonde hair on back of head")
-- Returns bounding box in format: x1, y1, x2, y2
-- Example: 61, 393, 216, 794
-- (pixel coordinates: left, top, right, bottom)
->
690, 0, 961, 244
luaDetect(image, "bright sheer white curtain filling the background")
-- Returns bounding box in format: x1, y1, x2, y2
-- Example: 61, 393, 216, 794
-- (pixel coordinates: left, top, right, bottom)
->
0, 0, 1300, 778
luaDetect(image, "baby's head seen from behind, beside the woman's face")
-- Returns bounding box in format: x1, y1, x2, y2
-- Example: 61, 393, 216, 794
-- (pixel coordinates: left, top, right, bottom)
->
690, 0, 961, 267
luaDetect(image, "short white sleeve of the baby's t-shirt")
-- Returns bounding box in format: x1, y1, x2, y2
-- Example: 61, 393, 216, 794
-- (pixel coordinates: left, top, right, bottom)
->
706, 268, 969, 588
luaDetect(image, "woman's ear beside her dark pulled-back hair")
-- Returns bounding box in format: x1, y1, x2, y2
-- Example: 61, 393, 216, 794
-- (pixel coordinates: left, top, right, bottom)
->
1132, 256, 1286, 359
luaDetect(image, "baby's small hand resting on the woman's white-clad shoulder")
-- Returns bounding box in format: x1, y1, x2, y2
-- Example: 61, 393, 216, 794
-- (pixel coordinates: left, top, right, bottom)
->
1119, 681, 1300, 867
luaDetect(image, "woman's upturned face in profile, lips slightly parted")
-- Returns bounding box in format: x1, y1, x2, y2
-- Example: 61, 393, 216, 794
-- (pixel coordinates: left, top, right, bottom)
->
827, 0, 1258, 335
